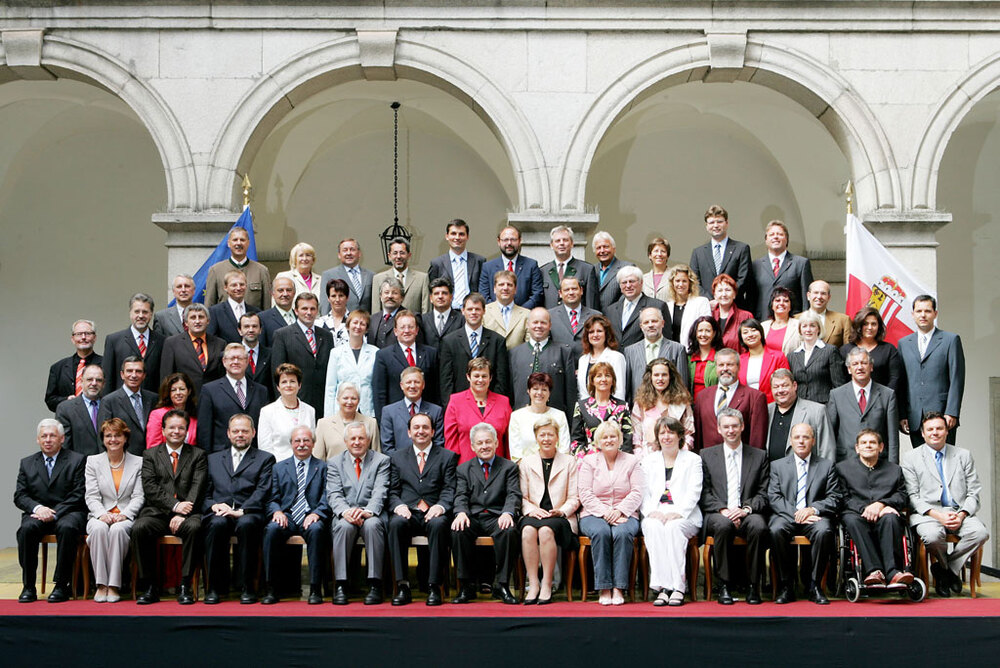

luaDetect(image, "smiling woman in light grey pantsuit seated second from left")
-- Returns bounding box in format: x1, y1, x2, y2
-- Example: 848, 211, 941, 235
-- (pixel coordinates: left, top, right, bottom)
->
84, 418, 145, 603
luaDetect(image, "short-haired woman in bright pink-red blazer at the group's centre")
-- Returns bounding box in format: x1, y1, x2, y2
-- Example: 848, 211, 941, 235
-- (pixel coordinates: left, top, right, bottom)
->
444, 357, 511, 464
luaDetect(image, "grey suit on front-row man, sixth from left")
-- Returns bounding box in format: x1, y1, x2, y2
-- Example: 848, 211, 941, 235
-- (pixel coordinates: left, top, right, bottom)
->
326, 450, 389, 580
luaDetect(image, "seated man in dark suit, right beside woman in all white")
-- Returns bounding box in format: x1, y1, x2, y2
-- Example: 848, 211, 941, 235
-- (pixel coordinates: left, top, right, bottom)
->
701, 408, 770, 605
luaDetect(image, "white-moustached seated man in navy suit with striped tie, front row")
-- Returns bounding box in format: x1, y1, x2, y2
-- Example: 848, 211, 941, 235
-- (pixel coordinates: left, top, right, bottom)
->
260, 425, 330, 605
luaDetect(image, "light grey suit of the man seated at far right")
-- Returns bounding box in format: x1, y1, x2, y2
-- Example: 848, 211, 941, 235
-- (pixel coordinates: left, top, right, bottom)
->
902, 443, 990, 575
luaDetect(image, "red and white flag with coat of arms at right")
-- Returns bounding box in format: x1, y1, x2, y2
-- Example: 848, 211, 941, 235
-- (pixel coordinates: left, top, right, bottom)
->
846, 213, 933, 345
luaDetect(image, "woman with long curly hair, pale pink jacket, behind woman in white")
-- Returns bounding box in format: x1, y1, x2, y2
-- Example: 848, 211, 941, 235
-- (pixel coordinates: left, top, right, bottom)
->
632, 357, 694, 459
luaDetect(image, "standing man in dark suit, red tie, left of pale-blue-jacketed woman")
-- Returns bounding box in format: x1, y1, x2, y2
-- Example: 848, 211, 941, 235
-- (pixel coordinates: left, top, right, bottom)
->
271, 292, 333, 420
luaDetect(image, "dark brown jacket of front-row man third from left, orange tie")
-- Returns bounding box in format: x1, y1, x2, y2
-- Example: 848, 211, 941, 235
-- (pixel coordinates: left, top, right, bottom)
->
139, 443, 208, 520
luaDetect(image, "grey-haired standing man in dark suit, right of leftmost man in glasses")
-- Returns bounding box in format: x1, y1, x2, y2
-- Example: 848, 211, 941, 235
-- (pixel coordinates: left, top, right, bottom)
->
101, 292, 164, 392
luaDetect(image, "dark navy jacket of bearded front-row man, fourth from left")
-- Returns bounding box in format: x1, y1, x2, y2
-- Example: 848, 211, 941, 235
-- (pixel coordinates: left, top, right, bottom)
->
202, 447, 274, 515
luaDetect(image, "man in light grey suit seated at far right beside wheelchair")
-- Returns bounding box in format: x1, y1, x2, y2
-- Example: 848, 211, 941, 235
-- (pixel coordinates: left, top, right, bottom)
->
903, 412, 990, 597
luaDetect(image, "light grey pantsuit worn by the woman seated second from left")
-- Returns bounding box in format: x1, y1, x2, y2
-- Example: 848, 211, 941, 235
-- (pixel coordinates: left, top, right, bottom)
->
84, 452, 146, 587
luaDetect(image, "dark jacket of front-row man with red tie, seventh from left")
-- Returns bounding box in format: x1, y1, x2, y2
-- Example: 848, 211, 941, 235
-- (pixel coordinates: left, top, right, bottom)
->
387, 444, 458, 512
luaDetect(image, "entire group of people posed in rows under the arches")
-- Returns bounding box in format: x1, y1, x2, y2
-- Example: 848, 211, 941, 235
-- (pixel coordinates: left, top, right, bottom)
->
16, 206, 985, 605
